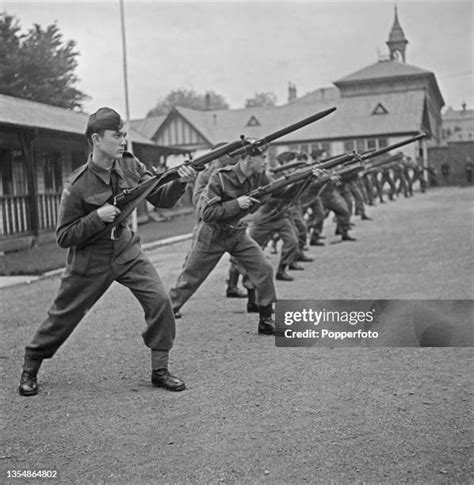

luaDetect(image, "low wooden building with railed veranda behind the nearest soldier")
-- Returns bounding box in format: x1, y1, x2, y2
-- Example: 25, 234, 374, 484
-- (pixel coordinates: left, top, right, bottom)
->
0, 95, 183, 252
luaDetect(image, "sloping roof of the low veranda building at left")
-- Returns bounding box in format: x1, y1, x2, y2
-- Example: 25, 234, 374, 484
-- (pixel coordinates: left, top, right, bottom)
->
0, 94, 156, 145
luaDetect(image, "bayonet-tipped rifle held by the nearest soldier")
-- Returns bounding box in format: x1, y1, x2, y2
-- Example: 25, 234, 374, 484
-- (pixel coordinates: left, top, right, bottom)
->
86, 108, 336, 243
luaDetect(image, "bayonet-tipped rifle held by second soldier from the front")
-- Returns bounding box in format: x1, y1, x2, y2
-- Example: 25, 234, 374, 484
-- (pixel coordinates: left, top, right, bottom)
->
245, 133, 426, 199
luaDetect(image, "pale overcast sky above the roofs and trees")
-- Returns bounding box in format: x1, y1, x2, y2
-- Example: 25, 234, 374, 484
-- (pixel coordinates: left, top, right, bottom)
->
0, 0, 474, 119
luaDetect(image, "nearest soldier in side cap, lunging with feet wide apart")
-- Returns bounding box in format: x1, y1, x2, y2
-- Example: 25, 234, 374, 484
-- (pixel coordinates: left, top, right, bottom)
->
19, 108, 195, 396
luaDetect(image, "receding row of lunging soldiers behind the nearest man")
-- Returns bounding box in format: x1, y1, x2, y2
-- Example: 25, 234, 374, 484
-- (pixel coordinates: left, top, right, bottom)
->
170, 143, 425, 334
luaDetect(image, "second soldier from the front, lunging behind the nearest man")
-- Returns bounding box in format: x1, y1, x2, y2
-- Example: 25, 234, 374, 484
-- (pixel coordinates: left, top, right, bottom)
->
170, 147, 316, 335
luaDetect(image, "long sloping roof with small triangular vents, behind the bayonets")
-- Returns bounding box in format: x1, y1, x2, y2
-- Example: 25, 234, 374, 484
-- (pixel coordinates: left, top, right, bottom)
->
161, 90, 425, 145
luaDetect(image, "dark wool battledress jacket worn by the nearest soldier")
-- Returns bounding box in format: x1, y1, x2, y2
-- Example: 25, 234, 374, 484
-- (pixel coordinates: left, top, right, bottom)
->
56, 152, 186, 274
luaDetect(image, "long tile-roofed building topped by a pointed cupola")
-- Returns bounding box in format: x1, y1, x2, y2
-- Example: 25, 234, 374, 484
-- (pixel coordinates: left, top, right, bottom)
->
136, 8, 444, 170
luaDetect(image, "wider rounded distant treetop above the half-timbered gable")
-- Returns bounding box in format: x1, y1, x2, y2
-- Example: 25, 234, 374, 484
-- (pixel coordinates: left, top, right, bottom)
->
147, 89, 229, 117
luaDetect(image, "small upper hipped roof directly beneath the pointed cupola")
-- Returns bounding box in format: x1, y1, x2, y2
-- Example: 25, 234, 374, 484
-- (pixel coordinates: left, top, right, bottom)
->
334, 60, 433, 86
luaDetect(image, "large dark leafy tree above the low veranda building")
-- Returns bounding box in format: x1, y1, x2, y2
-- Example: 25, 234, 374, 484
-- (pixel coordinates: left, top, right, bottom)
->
0, 12, 88, 109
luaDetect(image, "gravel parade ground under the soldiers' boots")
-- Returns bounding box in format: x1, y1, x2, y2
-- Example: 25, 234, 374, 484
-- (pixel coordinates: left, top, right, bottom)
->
0, 187, 474, 484
